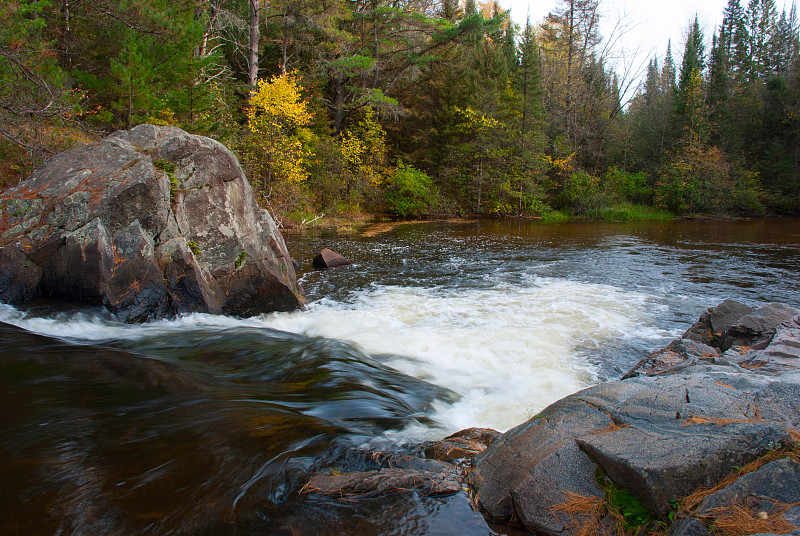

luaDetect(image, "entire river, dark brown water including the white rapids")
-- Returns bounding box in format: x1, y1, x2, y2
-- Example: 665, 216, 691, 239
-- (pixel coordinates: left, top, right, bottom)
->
0, 219, 800, 535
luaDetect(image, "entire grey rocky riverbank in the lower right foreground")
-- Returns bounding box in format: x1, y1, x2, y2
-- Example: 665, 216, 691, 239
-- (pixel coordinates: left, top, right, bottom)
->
305, 301, 800, 536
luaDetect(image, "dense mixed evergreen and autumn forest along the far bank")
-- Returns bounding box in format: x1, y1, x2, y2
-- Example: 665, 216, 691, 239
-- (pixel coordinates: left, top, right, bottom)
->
0, 0, 800, 226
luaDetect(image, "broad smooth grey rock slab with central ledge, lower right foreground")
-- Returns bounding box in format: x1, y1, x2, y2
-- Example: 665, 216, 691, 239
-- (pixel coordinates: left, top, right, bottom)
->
470, 362, 800, 535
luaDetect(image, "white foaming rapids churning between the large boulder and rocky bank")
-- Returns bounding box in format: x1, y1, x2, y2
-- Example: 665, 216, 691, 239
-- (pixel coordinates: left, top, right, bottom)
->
0, 276, 669, 440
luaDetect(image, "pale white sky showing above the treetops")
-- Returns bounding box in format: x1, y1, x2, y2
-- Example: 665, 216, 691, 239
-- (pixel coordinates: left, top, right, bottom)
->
501, 0, 732, 98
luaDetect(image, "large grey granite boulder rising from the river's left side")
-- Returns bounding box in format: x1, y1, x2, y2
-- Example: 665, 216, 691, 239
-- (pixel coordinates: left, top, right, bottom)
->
0, 125, 304, 322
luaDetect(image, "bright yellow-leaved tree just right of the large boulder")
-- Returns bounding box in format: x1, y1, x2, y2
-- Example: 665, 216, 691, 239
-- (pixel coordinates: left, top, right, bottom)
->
246, 73, 314, 199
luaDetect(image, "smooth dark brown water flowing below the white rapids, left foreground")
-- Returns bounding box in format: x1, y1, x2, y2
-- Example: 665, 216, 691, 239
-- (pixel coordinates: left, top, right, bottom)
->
0, 324, 452, 534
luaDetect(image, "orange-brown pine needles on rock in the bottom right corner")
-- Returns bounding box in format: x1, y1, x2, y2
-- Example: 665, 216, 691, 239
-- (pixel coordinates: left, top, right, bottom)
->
708, 500, 800, 536
